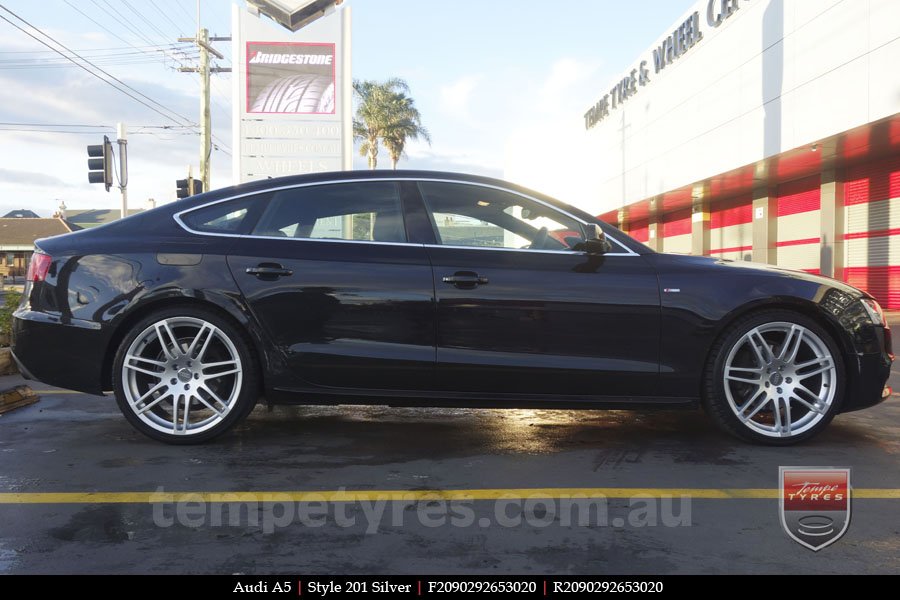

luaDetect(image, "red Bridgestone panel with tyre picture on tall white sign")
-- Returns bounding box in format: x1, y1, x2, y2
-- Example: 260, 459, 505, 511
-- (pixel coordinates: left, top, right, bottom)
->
247, 42, 335, 115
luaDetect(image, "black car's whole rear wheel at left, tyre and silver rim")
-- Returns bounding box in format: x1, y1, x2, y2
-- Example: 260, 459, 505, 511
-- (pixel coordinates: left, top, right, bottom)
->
113, 307, 258, 444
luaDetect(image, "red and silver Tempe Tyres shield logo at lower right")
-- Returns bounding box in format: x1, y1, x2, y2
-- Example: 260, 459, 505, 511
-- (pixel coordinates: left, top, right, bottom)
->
778, 467, 850, 551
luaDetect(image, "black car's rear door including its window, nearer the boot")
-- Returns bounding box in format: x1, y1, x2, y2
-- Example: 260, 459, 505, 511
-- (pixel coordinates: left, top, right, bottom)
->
228, 180, 435, 390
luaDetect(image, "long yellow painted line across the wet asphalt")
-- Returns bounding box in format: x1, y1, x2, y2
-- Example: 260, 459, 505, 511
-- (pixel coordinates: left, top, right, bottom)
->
0, 488, 900, 504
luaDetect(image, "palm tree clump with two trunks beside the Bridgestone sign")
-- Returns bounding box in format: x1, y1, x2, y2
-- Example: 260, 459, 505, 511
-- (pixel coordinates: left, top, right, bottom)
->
353, 77, 431, 169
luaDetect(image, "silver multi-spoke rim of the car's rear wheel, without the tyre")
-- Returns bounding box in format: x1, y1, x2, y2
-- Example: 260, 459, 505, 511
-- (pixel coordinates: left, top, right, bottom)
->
122, 317, 243, 436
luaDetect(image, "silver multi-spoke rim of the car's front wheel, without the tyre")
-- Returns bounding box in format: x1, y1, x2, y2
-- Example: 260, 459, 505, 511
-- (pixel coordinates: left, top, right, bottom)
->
722, 321, 837, 438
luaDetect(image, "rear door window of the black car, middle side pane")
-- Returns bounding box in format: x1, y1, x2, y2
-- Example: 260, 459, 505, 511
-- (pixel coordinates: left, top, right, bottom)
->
253, 181, 406, 242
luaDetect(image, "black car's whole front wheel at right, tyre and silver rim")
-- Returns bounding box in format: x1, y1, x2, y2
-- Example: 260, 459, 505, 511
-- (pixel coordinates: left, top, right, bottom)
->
704, 311, 844, 446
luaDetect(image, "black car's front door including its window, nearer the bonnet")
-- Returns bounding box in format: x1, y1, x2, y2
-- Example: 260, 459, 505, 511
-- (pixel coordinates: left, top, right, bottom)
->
419, 181, 660, 396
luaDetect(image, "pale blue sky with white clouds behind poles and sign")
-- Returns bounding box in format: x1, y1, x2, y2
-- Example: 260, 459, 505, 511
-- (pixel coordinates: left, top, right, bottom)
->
0, 0, 692, 216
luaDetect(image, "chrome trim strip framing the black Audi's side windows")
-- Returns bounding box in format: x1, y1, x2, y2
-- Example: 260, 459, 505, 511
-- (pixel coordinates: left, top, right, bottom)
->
172, 177, 640, 256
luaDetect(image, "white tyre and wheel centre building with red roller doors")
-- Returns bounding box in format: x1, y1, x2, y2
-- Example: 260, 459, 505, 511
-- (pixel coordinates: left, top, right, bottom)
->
582, 0, 900, 309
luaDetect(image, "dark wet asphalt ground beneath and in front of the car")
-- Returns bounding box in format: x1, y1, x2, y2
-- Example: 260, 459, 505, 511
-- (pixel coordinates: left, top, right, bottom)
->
0, 322, 900, 575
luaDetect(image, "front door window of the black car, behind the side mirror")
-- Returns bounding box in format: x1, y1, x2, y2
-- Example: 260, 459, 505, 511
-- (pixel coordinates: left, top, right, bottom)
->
419, 181, 584, 251
